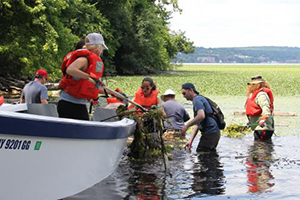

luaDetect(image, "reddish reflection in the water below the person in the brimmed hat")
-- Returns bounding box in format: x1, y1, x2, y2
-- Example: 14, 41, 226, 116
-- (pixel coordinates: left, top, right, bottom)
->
245, 141, 275, 193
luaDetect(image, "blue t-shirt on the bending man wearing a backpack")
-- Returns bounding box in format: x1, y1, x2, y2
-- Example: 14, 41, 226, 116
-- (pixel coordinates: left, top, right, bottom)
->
193, 95, 220, 134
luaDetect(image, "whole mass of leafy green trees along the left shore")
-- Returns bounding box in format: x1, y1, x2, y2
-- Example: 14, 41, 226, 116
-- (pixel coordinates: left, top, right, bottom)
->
0, 0, 193, 78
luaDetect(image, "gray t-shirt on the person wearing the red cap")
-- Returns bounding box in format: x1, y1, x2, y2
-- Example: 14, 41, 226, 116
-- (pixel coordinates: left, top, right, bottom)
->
21, 81, 48, 103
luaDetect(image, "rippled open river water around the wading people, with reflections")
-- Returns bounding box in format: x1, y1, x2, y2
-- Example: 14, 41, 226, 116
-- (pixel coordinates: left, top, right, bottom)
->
65, 97, 300, 200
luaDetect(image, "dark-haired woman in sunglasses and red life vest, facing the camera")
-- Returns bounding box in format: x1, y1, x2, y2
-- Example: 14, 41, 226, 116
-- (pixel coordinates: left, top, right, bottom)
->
129, 77, 161, 110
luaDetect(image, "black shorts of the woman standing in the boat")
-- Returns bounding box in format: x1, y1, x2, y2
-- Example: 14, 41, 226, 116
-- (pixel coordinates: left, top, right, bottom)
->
57, 100, 90, 120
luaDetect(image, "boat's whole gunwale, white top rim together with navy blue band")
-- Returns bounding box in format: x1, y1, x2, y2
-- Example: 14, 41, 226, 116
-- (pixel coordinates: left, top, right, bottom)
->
0, 111, 136, 139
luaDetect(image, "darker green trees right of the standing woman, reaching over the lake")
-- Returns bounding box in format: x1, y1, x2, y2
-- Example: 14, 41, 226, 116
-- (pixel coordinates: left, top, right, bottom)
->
97, 0, 192, 74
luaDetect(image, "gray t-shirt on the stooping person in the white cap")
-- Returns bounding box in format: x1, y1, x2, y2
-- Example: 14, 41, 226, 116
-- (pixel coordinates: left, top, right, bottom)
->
163, 100, 190, 130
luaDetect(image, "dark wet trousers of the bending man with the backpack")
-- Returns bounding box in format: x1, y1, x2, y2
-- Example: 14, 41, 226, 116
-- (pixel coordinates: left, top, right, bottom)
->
197, 131, 221, 152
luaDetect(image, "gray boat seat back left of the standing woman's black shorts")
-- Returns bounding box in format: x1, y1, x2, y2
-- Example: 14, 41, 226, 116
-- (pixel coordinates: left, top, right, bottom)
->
27, 103, 58, 117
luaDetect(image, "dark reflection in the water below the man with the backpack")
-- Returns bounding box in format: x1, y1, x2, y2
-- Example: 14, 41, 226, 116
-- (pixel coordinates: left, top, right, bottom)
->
187, 152, 225, 198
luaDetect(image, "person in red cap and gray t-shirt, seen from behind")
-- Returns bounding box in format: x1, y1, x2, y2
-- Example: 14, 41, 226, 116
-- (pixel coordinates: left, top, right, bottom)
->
20, 69, 48, 104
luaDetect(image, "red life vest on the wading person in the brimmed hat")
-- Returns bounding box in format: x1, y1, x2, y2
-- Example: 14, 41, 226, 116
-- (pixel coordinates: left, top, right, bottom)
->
246, 88, 274, 116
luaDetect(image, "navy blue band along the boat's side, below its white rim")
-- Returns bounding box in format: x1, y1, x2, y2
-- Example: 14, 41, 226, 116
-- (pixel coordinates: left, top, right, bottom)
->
0, 116, 136, 139
